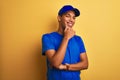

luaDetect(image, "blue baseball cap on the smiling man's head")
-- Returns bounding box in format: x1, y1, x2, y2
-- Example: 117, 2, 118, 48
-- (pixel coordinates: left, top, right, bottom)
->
58, 5, 80, 17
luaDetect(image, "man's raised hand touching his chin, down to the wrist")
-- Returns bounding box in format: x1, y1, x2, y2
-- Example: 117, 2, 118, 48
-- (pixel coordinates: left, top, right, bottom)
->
64, 27, 75, 40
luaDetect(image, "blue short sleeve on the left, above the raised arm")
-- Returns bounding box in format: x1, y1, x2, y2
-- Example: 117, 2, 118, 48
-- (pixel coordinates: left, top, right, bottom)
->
42, 34, 55, 55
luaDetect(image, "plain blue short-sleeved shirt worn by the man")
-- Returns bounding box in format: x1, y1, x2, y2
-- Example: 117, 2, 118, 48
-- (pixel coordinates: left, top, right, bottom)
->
42, 32, 86, 80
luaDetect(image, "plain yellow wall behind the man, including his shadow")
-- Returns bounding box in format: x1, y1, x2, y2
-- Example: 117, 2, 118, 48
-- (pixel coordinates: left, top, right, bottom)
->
0, 0, 120, 80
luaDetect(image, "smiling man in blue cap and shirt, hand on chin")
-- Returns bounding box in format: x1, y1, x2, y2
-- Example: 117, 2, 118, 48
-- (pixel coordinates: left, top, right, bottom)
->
42, 5, 88, 80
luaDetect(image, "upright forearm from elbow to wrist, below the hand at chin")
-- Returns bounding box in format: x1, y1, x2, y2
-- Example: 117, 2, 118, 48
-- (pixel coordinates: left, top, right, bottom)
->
51, 37, 69, 67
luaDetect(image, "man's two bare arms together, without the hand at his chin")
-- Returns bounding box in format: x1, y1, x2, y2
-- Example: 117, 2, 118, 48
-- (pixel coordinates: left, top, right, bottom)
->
45, 38, 88, 71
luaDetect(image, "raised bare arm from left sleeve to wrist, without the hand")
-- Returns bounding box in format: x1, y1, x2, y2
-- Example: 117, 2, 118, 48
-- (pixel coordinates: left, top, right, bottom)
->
45, 38, 68, 68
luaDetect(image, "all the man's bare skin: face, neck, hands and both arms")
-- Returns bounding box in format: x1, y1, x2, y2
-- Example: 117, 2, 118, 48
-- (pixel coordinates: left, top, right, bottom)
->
45, 11, 88, 71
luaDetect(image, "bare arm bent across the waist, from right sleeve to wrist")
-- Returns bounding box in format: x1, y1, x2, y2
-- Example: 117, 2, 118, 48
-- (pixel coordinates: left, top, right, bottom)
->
66, 53, 88, 71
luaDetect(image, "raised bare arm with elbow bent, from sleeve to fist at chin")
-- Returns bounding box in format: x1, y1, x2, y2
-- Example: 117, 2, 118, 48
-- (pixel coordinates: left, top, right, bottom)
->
45, 28, 75, 68
